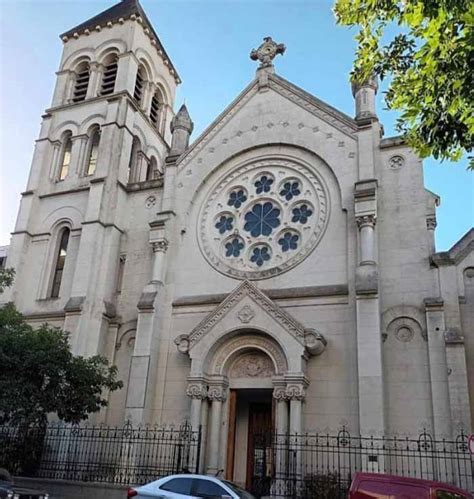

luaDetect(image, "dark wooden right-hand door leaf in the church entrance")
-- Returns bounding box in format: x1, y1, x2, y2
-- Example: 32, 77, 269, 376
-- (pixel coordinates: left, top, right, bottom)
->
246, 402, 272, 490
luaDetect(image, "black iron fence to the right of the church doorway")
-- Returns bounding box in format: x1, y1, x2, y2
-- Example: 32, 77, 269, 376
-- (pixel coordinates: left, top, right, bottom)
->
252, 429, 474, 499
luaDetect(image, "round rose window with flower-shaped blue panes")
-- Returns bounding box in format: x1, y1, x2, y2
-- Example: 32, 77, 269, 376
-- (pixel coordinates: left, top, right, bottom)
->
198, 159, 329, 279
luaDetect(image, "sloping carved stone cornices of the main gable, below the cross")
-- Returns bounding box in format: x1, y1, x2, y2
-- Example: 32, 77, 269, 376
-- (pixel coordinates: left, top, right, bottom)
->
178, 74, 358, 166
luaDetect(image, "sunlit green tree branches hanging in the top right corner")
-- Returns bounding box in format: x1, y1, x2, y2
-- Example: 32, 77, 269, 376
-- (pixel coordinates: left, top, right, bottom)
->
334, 0, 474, 169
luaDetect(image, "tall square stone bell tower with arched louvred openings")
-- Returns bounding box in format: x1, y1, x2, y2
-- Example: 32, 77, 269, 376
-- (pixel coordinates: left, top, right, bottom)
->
2, 0, 180, 368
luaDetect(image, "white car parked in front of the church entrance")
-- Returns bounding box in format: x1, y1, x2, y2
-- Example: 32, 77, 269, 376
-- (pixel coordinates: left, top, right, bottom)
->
127, 475, 255, 499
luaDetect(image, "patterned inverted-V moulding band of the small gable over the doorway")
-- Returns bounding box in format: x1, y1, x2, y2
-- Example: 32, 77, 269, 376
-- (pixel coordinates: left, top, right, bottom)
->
186, 280, 305, 348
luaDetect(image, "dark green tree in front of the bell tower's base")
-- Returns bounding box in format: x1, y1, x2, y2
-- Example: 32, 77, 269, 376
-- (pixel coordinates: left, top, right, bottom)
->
0, 271, 123, 425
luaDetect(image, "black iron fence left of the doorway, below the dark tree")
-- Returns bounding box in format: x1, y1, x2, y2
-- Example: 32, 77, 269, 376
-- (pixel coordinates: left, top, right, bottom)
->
0, 423, 201, 485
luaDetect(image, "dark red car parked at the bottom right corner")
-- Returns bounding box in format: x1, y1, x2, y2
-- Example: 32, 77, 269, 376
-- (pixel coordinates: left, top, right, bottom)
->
349, 473, 474, 499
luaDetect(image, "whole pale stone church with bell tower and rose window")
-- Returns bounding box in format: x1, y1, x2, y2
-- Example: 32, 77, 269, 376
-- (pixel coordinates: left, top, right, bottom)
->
2, 0, 474, 483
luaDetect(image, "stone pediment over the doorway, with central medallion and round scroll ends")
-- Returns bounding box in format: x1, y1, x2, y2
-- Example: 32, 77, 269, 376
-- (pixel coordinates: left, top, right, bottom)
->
175, 280, 326, 355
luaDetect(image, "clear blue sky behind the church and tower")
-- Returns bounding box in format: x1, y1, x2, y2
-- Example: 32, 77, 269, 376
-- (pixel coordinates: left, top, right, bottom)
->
0, 0, 474, 251
